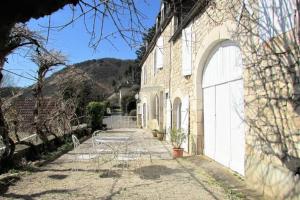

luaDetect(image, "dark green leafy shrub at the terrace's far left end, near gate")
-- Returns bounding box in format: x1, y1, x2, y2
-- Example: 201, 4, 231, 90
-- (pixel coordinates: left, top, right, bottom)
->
87, 101, 106, 131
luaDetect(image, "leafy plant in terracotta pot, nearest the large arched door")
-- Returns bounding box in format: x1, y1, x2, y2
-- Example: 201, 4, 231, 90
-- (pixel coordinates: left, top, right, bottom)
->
170, 129, 185, 158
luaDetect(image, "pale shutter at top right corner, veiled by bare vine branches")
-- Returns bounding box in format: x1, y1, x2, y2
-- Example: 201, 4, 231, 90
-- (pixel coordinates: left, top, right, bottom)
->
259, 0, 297, 41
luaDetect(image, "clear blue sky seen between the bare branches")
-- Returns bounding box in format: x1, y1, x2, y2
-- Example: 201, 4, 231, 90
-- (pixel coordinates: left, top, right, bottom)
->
5, 0, 160, 87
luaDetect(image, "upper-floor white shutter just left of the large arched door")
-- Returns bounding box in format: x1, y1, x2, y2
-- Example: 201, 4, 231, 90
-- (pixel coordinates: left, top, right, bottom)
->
181, 24, 192, 76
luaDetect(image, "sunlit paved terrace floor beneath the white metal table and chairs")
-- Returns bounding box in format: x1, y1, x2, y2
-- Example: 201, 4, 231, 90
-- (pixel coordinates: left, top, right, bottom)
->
0, 129, 258, 200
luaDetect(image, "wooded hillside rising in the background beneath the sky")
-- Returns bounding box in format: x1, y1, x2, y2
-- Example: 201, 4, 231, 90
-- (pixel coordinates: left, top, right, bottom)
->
0, 58, 139, 99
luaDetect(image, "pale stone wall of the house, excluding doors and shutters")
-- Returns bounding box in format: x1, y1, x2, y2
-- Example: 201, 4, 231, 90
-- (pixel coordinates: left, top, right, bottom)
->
139, 0, 300, 199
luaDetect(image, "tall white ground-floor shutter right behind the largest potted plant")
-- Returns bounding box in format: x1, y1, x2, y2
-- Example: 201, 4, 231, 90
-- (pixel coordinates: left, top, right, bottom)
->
181, 96, 190, 152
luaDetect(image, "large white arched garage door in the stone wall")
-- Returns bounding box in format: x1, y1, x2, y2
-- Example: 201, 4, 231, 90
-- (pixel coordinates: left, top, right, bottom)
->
203, 42, 245, 175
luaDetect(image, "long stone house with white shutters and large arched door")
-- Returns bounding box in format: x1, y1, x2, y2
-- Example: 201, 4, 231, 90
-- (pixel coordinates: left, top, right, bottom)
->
137, 0, 300, 199
